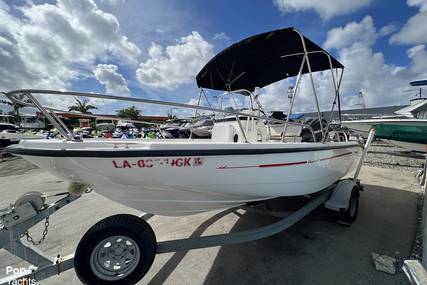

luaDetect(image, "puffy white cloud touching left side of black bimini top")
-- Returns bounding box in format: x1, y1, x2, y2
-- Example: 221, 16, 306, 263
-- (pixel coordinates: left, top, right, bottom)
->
136, 31, 213, 90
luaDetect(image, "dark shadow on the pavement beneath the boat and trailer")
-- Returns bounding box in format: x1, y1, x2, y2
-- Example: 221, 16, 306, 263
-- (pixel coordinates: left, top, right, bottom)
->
145, 185, 418, 284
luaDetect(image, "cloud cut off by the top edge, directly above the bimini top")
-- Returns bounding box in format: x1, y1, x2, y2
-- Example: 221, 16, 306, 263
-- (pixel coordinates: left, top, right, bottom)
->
273, 0, 371, 20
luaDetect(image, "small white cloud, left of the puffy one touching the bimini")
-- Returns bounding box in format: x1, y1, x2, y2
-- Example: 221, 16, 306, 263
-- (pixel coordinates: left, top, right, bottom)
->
93, 64, 130, 96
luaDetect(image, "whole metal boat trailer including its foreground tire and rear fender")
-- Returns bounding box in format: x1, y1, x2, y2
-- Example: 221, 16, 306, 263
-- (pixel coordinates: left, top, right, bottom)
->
0, 130, 375, 285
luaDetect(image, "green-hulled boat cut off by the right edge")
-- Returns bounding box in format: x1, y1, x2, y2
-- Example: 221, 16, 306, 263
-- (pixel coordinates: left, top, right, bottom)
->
342, 80, 427, 152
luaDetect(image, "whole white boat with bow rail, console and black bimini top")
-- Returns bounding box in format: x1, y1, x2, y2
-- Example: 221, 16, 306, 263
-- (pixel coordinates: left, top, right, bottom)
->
6, 28, 363, 216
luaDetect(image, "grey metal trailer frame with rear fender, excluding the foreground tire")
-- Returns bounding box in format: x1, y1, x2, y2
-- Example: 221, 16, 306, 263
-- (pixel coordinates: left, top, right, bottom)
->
0, 130, 375, 285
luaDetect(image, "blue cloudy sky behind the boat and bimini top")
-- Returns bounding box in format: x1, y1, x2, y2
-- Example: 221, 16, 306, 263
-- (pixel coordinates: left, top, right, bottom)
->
0, 0, 427, 115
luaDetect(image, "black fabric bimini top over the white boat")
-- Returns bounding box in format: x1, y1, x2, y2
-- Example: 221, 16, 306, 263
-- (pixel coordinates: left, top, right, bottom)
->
196, 28, 344, 91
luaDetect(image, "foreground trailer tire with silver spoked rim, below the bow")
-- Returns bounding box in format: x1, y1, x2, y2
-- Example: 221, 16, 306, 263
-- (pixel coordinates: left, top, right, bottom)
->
74, 214, 157, 285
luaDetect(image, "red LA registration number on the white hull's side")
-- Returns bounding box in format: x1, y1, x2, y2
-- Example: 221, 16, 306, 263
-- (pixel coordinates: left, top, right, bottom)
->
112, 157, 203, 168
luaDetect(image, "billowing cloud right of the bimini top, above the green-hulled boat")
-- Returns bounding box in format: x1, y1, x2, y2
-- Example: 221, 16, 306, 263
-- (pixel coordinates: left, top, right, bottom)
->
325, 17, 427, 106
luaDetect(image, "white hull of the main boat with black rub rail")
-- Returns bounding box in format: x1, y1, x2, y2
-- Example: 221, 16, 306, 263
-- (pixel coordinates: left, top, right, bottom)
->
10, 141, 361, 216
